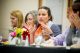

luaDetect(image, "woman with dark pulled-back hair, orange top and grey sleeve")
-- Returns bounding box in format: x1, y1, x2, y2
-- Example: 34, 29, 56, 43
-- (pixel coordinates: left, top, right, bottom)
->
34, 6, 61, 46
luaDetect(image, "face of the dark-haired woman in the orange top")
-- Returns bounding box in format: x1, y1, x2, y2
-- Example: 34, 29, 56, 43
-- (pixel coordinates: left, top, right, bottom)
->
38, 9, 50, 23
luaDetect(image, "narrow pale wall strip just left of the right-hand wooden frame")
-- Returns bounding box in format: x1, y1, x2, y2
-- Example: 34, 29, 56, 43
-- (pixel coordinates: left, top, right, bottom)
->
62, 0, 70, 32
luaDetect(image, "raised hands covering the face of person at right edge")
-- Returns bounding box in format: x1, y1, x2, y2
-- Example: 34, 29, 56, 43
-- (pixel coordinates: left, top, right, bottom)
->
68, 8, 80, 29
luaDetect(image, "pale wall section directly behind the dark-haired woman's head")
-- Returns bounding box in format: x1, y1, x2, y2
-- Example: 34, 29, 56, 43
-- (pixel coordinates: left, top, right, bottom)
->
43, 0, 63, 24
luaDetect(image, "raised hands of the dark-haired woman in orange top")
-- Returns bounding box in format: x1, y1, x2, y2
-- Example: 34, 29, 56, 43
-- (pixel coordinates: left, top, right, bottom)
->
40, 22, 52, 40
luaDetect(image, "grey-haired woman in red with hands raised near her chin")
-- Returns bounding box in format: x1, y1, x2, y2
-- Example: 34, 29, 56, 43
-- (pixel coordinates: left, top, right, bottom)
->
23, 11, 37, 44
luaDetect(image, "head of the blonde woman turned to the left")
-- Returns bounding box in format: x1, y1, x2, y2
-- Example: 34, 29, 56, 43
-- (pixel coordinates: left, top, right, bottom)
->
10, 10, 23, 29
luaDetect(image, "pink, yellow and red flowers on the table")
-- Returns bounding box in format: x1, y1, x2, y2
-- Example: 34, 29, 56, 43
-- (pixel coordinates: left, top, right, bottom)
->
10, 28, 30, 43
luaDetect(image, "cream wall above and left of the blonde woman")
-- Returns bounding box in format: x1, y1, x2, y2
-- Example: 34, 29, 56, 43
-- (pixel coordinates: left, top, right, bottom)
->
0, 0, 38, 38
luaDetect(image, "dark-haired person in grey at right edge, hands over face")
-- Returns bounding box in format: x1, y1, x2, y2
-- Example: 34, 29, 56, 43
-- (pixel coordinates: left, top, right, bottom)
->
66, 0, 80, 46
